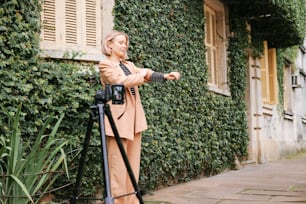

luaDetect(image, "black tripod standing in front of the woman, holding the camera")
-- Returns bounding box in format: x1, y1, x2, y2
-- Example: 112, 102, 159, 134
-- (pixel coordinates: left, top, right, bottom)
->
70, 90, 144, 204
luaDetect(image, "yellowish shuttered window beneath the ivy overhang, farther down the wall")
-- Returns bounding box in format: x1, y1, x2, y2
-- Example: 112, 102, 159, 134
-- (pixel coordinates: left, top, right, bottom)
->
260, 41, 278, 104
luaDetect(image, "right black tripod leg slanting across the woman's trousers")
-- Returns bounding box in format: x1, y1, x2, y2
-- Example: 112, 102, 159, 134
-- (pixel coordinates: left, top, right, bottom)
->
104, 104, 144, 204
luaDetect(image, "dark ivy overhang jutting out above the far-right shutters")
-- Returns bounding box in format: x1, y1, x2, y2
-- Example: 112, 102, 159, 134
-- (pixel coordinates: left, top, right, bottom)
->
223, 0, 306, 48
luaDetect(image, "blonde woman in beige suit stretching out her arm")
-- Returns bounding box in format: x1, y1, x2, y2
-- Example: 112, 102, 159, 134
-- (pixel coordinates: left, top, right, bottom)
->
99, 31, 180, 204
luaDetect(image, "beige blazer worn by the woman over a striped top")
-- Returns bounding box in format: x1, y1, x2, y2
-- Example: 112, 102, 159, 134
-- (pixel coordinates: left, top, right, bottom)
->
99, 59, 147, 140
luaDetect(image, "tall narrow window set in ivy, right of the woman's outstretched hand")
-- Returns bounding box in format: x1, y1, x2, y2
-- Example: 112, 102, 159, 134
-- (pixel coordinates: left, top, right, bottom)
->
204, 0, 228, 93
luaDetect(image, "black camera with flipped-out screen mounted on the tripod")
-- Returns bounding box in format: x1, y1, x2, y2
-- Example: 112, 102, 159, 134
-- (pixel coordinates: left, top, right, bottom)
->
95, 84, 125, 104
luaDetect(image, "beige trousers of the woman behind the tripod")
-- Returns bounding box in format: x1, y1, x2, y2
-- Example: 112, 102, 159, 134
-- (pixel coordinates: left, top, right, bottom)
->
106, 133, 141, 204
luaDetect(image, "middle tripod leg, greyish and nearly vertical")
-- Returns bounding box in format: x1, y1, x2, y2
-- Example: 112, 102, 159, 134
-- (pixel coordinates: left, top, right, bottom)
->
97, 104, 114, 204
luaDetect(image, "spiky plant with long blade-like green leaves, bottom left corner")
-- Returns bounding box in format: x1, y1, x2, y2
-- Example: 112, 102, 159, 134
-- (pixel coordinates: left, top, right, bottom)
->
0, 105, 68, 204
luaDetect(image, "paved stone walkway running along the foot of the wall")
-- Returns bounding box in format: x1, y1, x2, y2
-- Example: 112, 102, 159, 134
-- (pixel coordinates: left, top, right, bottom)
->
143, 153, 306, 204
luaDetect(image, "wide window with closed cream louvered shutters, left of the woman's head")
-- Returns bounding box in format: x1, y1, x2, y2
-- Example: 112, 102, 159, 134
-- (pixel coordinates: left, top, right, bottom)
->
41, 0, 102, 60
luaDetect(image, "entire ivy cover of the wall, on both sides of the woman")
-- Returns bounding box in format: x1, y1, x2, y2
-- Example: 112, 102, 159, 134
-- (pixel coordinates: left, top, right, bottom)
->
0, 0, 304, 201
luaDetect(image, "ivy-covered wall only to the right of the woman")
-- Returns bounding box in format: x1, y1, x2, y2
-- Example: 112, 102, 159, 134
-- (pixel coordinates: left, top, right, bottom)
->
114, 0, 248, 189
